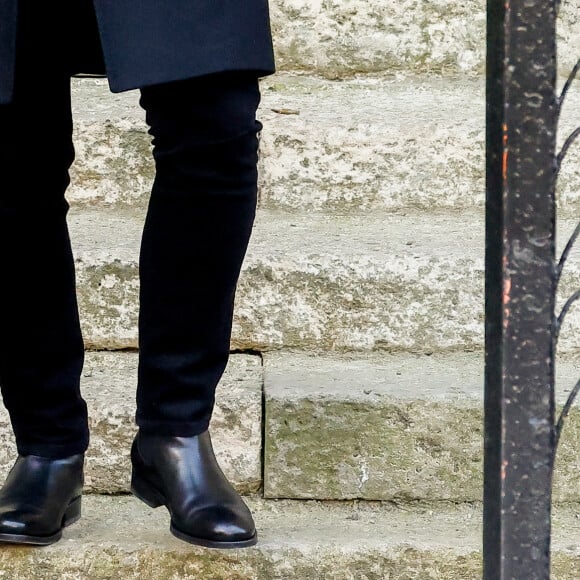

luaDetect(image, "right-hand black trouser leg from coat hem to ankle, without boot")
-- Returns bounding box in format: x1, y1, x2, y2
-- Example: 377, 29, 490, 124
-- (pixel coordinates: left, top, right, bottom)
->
137, 74, 260, 436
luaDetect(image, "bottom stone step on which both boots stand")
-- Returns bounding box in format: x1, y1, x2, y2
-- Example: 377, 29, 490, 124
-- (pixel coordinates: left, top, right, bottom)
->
0, 496, 580, 580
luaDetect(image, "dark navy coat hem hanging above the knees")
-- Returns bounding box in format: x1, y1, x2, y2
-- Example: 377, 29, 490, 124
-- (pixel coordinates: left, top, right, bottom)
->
0, 0, 274, 103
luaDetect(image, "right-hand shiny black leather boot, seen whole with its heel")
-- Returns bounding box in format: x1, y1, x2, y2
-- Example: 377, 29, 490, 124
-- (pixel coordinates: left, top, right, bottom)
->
131, 431, 257, 548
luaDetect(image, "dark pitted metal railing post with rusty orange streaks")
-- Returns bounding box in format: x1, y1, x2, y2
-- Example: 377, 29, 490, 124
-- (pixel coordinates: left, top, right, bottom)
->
483, 0, 557, 580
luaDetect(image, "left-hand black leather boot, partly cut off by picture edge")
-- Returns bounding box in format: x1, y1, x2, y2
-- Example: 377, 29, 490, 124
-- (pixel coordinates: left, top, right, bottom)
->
0, 454, 84, 546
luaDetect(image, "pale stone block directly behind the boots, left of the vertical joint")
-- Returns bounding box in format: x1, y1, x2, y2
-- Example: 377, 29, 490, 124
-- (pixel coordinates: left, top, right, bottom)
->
0, 353, 262, 494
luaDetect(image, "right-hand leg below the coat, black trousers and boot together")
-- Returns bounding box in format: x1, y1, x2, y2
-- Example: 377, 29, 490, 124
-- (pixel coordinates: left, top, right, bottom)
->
133, 73, 261, 547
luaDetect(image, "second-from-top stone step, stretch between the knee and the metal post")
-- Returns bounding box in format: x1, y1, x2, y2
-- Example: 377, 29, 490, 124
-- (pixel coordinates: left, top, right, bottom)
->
260, 76, 485, 212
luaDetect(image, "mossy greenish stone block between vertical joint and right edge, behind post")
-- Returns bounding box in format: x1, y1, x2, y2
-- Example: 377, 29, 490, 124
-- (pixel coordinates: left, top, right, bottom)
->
264, 353, 580, 502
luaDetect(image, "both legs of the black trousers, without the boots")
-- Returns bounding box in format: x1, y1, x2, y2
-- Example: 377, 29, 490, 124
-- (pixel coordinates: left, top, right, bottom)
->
0, 0, 261, 457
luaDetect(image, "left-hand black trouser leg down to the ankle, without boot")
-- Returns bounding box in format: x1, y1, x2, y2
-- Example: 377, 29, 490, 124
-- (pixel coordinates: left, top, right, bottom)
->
0, 1, 88, 457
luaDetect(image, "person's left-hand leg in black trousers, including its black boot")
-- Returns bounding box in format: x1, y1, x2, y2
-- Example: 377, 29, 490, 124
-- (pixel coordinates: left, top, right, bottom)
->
0, 0, 88, 544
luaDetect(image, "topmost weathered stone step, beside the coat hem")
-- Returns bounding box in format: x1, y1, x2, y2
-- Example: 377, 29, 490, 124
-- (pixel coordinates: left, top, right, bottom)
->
270, 0, 580, 78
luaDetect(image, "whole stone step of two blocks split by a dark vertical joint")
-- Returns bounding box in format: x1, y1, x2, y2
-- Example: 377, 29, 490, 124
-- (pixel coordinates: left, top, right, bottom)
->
0, 353, 580, 504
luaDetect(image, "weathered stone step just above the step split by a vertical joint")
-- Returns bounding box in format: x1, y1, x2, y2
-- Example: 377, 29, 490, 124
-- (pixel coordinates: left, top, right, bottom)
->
70, 208, 580, 353
